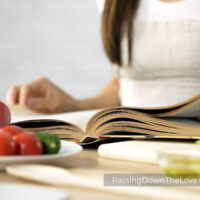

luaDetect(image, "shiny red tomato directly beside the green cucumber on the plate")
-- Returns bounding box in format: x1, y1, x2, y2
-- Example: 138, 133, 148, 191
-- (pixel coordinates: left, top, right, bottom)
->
13, 132, 43, 155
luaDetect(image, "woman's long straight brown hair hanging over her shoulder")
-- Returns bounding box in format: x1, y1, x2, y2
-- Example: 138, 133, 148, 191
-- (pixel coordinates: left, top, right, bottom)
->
102, 0, 139, 66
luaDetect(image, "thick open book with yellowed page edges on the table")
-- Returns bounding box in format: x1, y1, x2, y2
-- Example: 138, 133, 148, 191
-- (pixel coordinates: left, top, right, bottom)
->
11, 94, 200, 144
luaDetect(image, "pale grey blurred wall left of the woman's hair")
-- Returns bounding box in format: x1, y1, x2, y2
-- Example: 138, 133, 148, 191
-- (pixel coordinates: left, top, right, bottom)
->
0, 0, 111, 100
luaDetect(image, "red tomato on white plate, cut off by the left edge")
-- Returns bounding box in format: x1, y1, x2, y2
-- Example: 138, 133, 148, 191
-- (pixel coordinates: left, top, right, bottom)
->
0, 132, 16, 156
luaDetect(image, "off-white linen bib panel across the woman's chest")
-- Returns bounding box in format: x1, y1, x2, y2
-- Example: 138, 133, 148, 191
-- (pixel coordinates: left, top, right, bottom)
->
132, 20, 200, 79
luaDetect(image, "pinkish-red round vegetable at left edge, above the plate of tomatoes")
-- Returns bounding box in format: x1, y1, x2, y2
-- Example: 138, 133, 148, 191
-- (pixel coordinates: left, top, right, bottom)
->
0, 101, 11, 128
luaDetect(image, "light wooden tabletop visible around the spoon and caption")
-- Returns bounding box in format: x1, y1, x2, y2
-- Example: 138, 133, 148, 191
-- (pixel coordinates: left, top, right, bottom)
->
0, 150, 200, 200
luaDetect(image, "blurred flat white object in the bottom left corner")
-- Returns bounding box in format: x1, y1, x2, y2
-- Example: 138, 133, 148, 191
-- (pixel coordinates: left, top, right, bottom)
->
0, 184, 68, 200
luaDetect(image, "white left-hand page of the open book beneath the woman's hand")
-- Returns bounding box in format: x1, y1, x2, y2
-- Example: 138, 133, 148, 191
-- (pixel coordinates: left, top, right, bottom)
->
9, 105, 99, 131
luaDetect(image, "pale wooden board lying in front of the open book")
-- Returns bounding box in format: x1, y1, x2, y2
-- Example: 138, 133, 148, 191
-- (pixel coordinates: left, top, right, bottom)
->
98, 141, 197, 164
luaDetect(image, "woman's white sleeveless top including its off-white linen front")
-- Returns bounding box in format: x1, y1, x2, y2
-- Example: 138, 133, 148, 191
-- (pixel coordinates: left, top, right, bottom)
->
97, 0, 200, 107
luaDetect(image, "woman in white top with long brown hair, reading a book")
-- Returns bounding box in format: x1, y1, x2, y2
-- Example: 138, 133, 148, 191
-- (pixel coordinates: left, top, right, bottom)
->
7, 0, 200, 113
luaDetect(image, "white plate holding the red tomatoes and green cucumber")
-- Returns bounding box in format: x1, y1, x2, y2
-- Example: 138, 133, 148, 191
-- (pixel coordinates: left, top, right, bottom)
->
0, 141, 82, 169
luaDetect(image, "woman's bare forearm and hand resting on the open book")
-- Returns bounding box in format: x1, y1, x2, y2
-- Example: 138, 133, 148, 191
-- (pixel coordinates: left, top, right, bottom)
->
7, 77, 120, 113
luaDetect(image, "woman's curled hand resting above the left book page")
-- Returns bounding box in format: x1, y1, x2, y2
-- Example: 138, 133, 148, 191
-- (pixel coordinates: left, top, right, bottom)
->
7, 77, 77, 113
